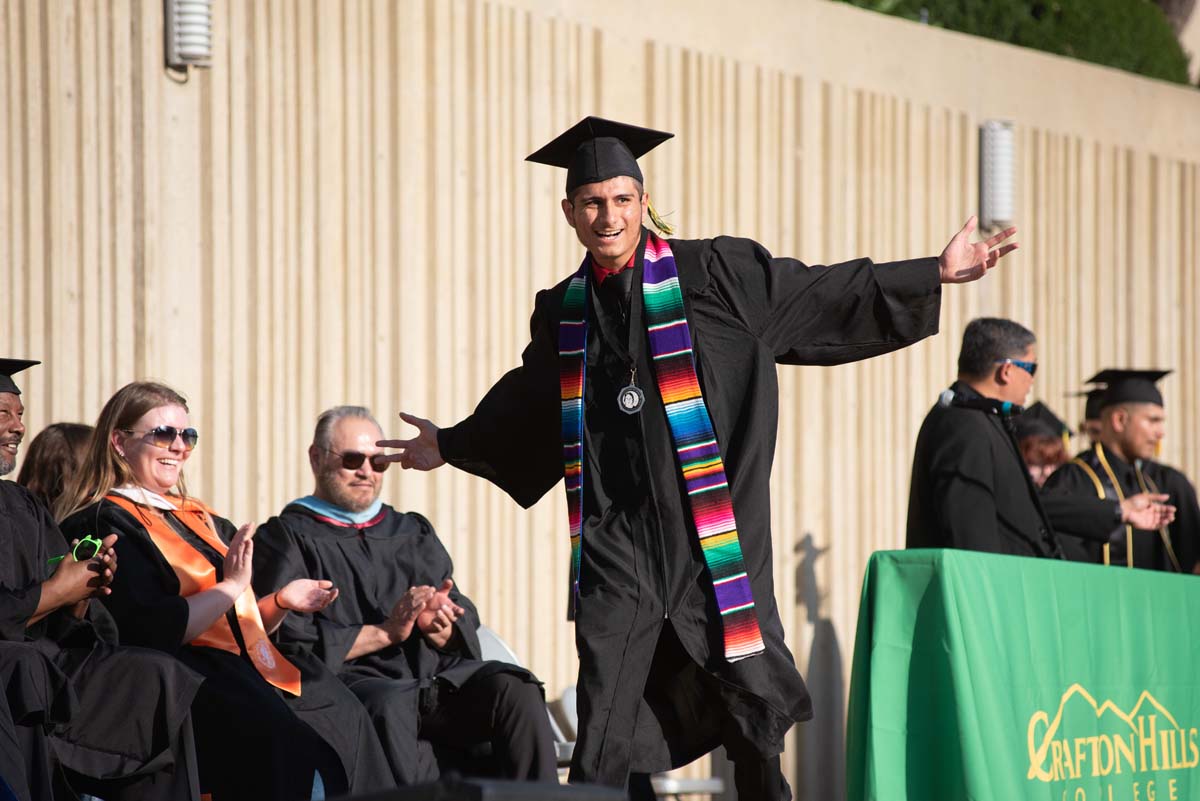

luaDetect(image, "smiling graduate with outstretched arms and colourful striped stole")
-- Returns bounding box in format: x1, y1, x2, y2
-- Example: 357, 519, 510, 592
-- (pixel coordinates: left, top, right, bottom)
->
380, 118, 1015, 800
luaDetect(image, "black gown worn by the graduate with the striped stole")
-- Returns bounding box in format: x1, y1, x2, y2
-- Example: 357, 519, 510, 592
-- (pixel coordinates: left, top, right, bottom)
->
438, 225, 941, 787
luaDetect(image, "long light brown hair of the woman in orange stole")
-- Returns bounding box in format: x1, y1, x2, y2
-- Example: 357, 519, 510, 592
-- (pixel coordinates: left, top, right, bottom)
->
54, 381, 187, 520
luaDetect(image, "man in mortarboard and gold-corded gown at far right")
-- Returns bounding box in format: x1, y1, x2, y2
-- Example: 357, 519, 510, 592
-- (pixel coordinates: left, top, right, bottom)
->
1045, 369, 1200, 573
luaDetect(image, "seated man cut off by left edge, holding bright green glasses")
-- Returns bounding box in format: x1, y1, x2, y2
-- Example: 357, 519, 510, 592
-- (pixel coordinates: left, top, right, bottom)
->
0, 360, 200, 801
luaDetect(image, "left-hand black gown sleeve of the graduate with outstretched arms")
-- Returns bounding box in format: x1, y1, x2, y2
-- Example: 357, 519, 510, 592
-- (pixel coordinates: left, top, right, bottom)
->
438, 288, 563, 508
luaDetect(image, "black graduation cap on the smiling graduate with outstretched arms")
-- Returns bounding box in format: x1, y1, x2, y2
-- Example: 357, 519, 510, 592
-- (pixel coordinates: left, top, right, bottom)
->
526, 116, 674, 194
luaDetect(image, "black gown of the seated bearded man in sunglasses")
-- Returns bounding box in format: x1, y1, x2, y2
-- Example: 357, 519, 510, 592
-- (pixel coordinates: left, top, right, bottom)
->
253, 504, 545, 784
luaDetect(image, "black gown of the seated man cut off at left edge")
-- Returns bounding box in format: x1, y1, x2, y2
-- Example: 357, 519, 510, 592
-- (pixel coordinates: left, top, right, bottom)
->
0, 481, 200, 801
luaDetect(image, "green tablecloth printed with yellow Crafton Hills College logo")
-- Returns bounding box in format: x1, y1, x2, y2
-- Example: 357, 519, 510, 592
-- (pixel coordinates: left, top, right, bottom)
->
846, 550, 1200, 801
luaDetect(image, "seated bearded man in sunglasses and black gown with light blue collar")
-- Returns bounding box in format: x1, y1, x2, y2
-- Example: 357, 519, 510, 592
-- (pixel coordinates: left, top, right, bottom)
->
254, 406, 558, 784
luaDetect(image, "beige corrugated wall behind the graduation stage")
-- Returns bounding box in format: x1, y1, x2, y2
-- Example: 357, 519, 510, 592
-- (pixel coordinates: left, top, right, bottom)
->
0, 0, 1200, 799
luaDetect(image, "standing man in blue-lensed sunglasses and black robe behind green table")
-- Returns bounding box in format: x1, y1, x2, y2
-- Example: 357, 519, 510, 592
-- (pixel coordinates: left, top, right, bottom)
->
907, 318, 1171, 559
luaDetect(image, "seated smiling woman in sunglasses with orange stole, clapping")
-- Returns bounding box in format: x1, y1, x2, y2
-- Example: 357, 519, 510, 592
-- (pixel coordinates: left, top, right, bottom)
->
62, 383, 392, 801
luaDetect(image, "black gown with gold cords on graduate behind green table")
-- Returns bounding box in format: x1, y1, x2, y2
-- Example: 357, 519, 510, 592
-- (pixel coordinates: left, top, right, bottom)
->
1043, 445, 1198, 572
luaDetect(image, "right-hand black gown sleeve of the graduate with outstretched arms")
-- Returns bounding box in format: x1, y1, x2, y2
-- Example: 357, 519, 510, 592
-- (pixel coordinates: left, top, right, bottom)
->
708, 236, 941, 365
